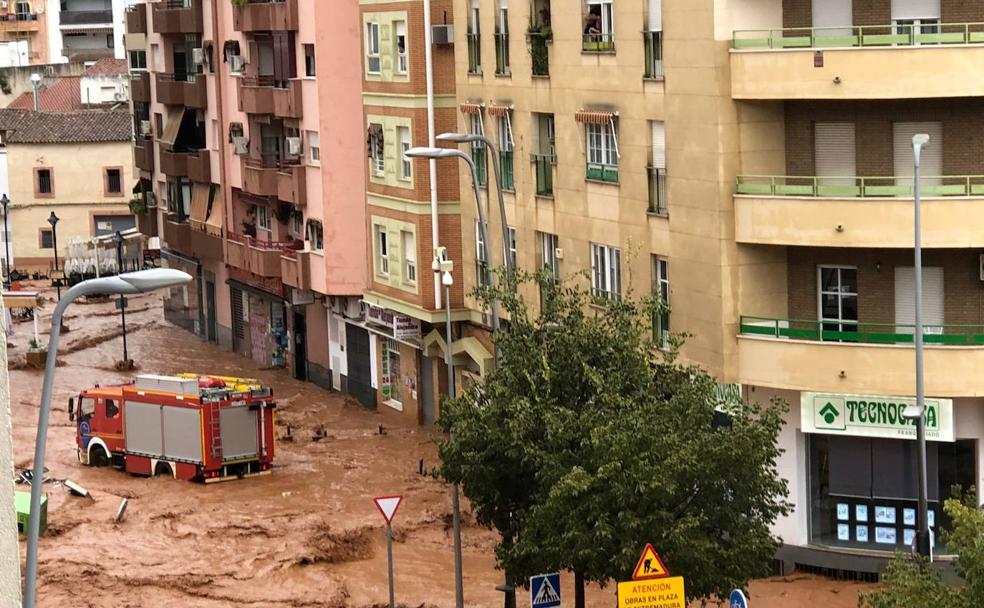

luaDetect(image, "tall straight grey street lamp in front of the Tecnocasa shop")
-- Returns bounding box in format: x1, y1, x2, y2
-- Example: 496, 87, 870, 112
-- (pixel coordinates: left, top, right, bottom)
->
902, 133, 933, 559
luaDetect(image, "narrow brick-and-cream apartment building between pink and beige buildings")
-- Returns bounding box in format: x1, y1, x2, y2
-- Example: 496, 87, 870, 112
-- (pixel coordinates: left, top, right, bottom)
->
360, 0, 468, 424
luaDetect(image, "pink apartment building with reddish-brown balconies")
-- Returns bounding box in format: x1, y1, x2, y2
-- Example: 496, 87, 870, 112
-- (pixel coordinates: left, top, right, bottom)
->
126, 0, 368, 388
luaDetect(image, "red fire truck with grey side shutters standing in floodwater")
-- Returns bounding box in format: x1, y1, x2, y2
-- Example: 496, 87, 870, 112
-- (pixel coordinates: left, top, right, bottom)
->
68, 374, 276, 482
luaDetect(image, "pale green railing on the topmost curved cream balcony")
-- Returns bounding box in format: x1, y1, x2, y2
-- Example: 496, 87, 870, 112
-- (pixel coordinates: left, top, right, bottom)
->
732, 23, 984, 49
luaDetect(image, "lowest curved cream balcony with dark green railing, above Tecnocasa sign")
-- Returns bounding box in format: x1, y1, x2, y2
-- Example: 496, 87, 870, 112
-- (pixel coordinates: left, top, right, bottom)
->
738, 317, 984, 397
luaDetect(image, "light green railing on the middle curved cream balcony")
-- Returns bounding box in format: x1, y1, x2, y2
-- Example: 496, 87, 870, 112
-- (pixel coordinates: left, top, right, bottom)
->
735, 175, 984, 198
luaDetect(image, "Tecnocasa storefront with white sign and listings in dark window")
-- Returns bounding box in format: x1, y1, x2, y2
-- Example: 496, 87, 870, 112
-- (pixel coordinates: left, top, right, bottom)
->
804, 392, 978, 554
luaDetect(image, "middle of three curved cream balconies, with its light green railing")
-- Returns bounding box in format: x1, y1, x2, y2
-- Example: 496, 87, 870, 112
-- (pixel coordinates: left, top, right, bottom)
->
735, 176, 984, 248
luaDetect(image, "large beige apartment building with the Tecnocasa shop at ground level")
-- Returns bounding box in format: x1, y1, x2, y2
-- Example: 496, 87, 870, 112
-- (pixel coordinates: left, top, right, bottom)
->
454, 0, 984, 572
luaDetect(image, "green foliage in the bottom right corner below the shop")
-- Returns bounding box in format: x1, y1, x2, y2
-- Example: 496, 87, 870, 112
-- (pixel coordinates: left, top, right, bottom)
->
858, 489, 984, 608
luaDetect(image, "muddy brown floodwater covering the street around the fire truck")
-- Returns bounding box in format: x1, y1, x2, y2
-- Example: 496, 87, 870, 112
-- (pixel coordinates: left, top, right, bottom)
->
1, 286, 876, 608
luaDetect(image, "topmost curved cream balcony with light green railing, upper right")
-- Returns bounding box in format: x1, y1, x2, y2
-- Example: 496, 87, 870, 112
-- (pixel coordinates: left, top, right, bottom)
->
731, 23, 984, 99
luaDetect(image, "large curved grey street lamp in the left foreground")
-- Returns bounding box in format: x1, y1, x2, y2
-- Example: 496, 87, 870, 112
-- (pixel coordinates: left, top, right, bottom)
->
23, 268, 191, 608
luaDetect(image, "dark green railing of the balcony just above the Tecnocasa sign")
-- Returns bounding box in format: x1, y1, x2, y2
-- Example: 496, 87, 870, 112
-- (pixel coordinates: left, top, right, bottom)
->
738, 316, 984, 346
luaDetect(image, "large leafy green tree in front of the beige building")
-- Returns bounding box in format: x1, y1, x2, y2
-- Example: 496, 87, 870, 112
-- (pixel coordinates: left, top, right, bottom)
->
439, 276, 789, 608
